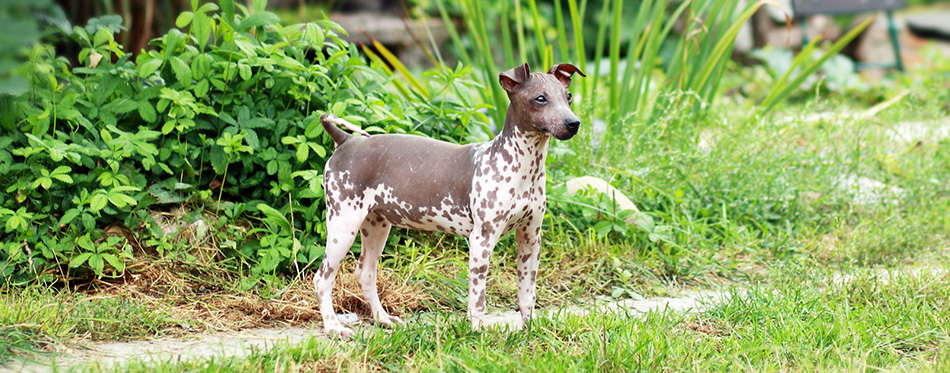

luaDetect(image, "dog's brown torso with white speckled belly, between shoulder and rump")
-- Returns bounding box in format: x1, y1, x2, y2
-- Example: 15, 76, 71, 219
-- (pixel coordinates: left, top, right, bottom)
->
324, 135, 482, 235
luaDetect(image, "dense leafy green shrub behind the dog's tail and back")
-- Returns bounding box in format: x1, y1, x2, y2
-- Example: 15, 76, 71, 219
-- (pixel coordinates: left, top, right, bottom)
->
0, 0, 473, 282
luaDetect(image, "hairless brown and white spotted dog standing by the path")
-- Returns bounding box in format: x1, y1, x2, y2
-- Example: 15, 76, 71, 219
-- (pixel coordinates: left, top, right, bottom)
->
313, 64, 585, 338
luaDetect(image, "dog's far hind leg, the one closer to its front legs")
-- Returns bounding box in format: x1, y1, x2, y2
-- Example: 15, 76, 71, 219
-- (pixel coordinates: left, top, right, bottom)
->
354, 212, 403, 326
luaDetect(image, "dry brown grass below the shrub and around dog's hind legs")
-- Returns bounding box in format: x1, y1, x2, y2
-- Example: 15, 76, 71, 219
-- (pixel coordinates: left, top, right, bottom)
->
80, 258, 427, 335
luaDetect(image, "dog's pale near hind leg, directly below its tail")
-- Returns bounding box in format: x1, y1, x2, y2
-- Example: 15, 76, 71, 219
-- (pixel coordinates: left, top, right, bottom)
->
313, 205, 367, 338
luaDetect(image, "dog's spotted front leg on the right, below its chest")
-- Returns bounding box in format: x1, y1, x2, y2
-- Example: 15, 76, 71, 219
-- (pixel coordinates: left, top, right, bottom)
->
515, 211, 544, 328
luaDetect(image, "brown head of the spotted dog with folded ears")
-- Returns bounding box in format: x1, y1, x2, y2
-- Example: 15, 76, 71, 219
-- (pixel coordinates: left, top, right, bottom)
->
498, 63, 587, 140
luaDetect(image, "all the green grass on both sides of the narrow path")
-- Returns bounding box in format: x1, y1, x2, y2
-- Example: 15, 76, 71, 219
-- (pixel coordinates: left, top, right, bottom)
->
7, 61, 950, 371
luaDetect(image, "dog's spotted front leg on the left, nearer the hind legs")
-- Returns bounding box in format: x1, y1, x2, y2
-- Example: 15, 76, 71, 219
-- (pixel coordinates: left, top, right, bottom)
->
468, 229, 498, 329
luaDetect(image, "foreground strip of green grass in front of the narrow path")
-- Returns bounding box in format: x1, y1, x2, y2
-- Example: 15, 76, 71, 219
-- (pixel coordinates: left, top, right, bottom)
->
70, 261, 950, 372
